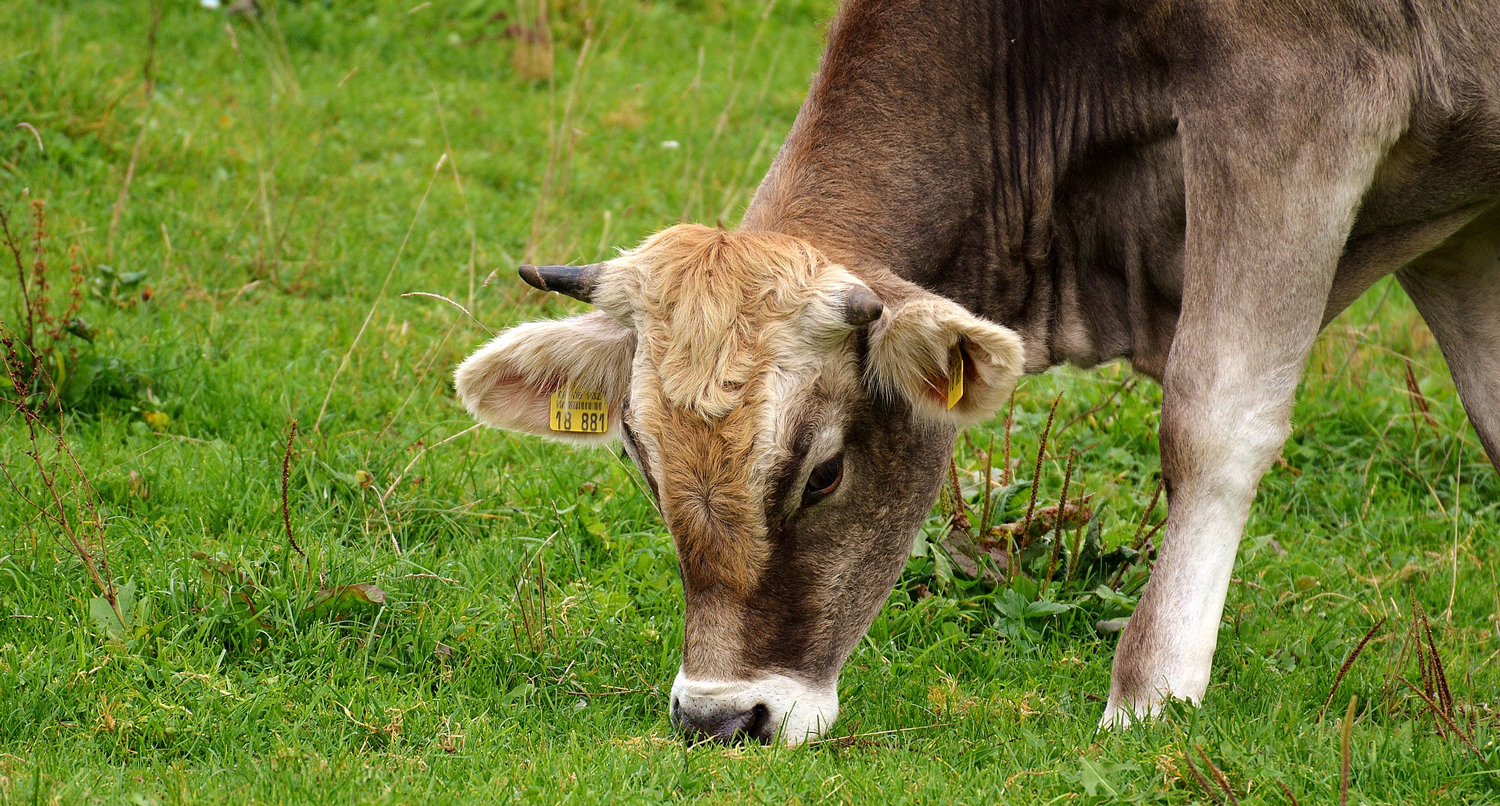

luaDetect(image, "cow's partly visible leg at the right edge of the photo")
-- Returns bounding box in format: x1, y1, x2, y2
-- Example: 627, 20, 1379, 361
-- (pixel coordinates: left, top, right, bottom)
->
1397, 209, 1500, 470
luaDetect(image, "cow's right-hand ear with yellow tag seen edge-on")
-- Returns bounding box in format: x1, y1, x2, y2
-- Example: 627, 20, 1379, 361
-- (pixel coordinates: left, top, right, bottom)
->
867, 291, 1025, 426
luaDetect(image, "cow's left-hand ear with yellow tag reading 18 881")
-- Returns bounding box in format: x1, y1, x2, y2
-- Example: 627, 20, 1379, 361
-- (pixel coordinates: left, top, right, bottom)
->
453, 311, 636, 444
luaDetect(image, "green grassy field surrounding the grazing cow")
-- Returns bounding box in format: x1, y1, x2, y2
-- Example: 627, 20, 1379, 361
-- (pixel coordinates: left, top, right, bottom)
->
0, 0, 1500, 803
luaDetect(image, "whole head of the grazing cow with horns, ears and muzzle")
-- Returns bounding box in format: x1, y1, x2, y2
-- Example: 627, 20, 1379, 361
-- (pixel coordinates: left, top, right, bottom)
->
456, 225, 1022, 743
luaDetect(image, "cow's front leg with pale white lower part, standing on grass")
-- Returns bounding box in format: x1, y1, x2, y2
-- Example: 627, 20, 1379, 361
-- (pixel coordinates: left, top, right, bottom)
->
1101, 93, 1394, 725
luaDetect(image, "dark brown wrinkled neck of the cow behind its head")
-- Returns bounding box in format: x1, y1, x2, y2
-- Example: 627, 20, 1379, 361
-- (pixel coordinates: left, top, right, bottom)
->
744, 0, 1182, 372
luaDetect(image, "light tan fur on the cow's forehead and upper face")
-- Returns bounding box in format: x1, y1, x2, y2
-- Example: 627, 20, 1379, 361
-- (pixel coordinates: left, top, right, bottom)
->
596, 225, 858, 593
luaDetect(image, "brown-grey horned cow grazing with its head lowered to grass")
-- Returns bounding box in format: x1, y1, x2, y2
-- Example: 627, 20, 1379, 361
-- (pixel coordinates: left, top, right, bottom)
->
456, 0, 1500, 743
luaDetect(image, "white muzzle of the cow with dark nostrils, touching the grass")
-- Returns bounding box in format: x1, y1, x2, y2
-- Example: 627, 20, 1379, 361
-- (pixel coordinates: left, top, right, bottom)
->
672, 671, 839, 744
